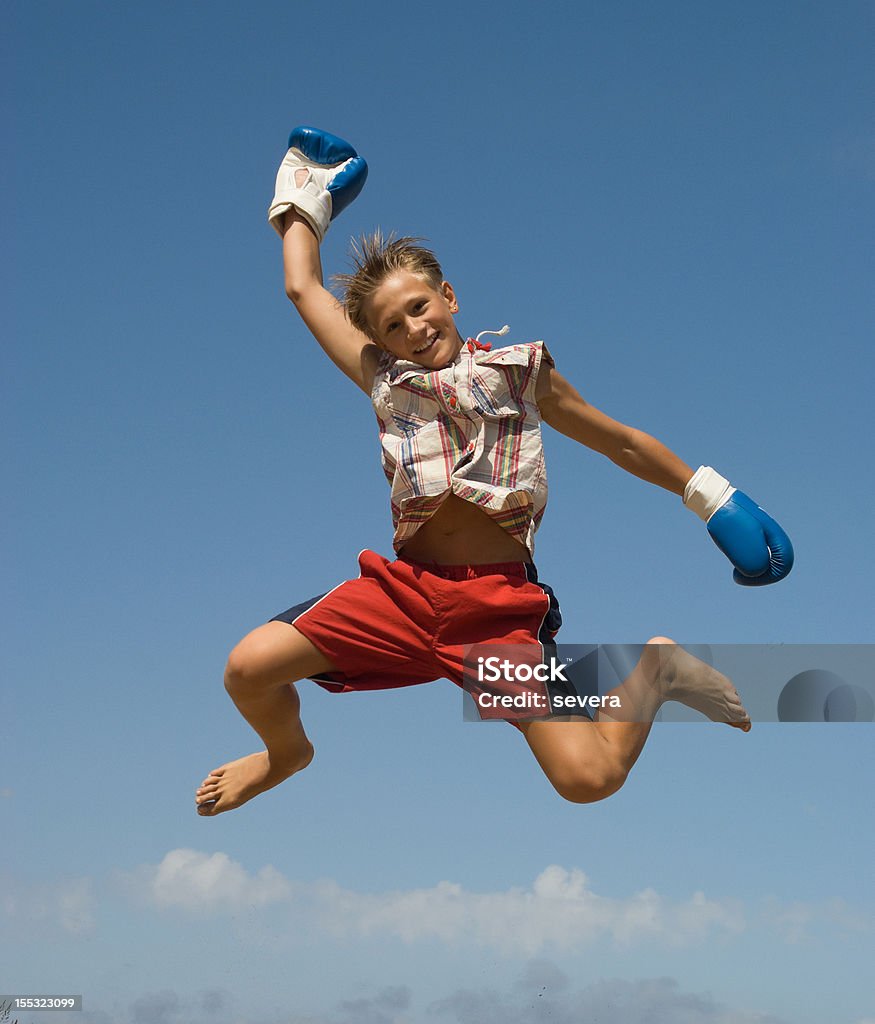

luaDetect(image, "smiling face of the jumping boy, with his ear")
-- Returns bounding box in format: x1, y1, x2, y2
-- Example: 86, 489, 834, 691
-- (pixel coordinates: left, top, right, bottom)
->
366, 270, 462, 370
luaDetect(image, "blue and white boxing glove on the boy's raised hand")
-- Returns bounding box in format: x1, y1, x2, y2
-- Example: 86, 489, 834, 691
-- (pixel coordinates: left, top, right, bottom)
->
267, 125, 368, 242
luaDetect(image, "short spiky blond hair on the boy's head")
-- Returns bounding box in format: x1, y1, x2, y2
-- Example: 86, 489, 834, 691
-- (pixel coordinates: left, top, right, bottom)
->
333, 228, 444, 341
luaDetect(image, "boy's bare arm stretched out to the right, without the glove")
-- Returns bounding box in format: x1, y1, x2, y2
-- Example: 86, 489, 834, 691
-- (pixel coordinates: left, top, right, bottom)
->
536, 361, 693, 495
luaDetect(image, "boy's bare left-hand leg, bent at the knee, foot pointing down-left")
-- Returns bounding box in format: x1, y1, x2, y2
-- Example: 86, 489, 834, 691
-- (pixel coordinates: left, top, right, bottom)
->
196, 622, 334, 816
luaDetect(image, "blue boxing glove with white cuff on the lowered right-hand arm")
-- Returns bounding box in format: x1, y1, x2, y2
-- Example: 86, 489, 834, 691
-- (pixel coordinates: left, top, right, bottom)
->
683, 466, 793, 587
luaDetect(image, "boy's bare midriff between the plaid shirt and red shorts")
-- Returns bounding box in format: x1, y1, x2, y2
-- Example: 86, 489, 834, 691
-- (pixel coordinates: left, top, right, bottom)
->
401, 495, 532, 565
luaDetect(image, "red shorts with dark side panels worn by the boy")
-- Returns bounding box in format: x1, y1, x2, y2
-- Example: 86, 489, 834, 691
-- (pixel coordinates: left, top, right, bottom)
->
272, 551, 561, 716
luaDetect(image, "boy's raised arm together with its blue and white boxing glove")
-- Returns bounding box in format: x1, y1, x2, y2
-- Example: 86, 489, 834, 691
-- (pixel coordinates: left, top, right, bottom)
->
267, 127, 379, 393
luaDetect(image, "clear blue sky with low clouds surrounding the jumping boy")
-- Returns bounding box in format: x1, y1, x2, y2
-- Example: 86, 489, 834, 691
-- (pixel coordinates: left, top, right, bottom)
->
0, 0, 875, 1024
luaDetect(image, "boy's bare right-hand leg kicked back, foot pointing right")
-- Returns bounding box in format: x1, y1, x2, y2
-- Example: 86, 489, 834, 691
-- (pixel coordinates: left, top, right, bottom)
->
520, 637, 750, 803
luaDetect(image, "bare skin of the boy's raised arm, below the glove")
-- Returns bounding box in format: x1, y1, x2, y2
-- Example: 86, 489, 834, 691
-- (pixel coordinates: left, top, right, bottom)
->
283, 210, 379, 394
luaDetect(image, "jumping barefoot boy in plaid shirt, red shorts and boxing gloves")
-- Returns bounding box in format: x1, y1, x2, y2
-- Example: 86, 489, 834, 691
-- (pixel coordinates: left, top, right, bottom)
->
196, 128, 793, 816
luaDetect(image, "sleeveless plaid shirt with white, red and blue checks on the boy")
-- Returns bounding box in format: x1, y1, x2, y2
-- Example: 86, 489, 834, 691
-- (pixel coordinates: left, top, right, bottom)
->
371, 340, 553, 553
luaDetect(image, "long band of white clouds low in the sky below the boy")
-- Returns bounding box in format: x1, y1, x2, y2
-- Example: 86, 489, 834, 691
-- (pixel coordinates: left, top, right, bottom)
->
128, 850, 745, 955
